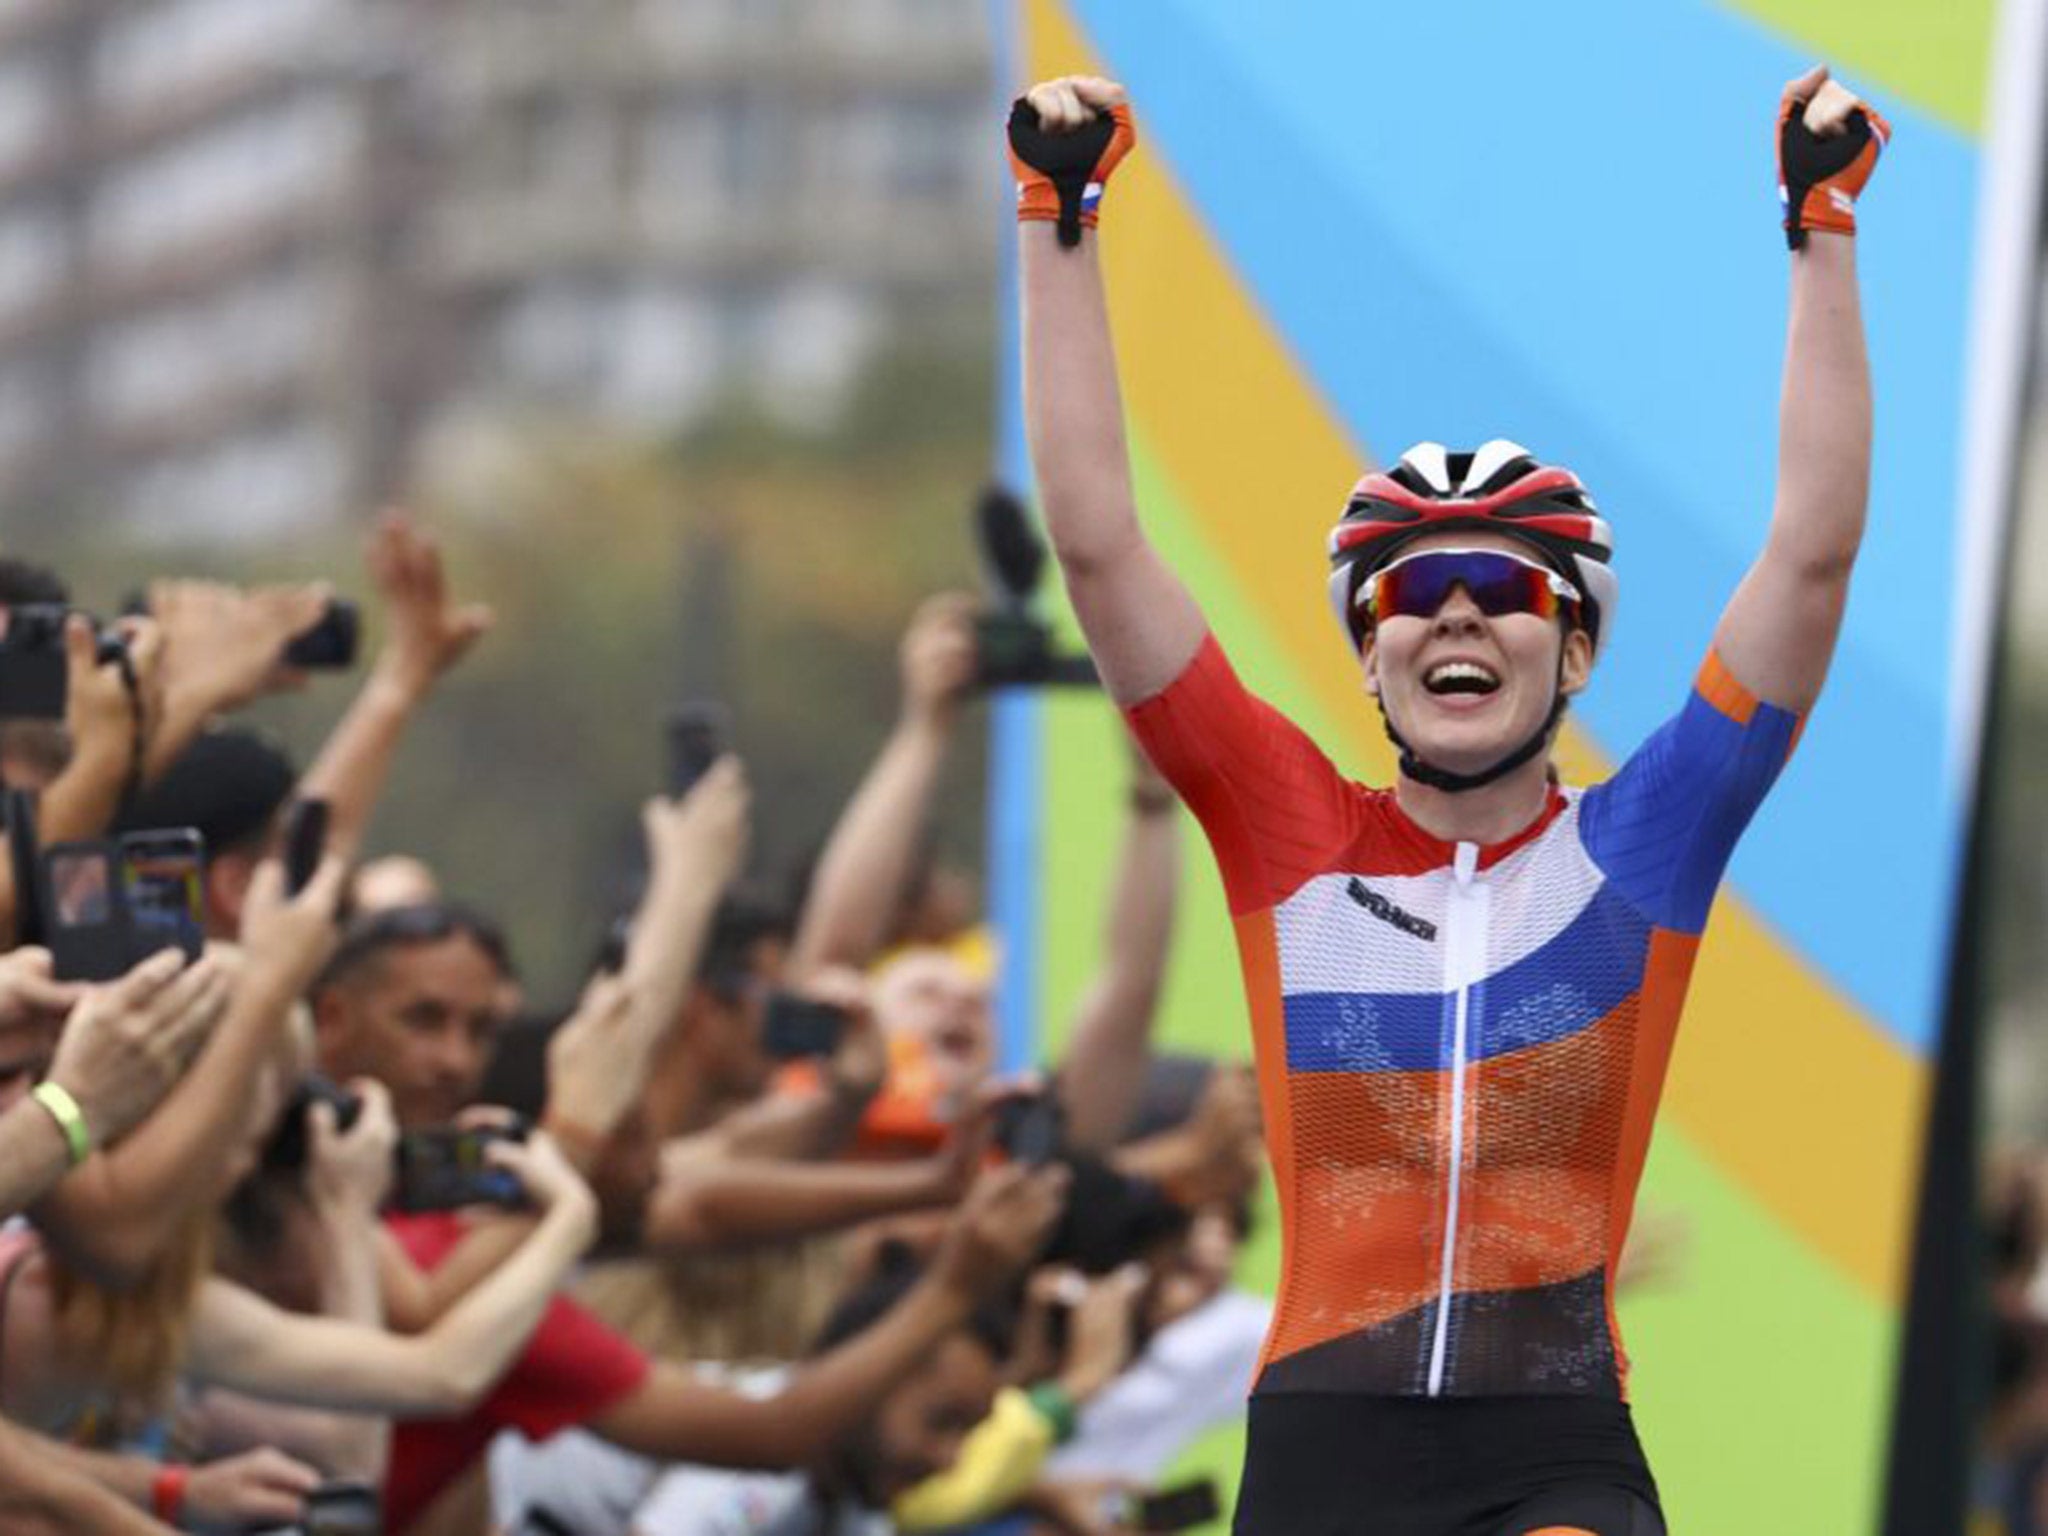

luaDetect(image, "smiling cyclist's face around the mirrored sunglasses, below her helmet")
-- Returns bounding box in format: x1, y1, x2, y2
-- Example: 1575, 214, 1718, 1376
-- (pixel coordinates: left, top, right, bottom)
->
1360, 532, 1593, 774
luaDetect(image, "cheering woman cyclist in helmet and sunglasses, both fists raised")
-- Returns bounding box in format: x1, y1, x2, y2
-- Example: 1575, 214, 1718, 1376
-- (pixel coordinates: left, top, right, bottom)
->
1010, 60, 1886, 1536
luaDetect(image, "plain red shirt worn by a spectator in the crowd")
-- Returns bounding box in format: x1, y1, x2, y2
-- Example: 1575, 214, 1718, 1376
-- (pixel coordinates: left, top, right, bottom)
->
383, 1212, 651, 1532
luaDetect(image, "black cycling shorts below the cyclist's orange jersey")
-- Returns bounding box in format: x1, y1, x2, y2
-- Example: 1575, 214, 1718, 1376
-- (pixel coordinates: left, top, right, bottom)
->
1233, 1393, 1665, 1536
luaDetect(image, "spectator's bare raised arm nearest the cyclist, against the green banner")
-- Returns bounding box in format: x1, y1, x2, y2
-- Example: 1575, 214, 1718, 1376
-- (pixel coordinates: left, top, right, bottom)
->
1059, 743, 1180, 1153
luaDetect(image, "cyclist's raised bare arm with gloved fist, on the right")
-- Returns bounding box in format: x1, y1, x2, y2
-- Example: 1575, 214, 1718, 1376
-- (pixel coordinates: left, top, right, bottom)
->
1714, 68, 1888, 711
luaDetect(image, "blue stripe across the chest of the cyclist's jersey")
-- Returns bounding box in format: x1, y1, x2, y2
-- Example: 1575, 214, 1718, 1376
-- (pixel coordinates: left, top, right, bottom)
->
1284, 885, 1651, 1071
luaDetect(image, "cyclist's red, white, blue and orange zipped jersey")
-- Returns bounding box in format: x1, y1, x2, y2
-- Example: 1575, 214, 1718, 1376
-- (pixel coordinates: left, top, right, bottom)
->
1128, 639, 1798, 1399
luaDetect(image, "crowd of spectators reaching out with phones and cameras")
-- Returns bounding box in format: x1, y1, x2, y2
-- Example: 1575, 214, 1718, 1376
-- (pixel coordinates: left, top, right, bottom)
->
0, 516, 1266, 1536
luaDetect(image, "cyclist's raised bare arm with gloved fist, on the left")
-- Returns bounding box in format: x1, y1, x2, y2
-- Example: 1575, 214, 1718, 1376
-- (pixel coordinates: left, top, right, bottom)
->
1012, 76, 1206, 705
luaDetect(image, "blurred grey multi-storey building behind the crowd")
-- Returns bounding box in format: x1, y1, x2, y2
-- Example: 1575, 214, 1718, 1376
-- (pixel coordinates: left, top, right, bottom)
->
0, 0, 999, 537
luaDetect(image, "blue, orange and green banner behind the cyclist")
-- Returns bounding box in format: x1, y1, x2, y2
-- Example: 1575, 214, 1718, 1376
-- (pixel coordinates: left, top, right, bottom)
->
991, 0, 2038, 1536
